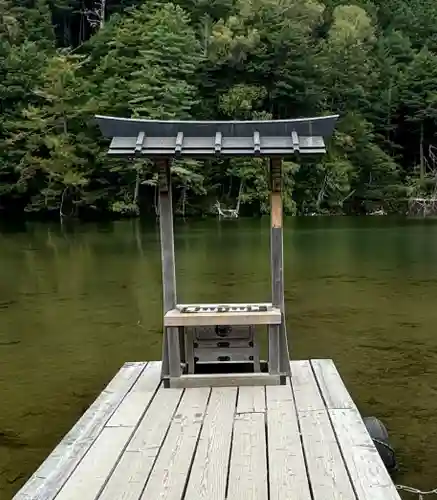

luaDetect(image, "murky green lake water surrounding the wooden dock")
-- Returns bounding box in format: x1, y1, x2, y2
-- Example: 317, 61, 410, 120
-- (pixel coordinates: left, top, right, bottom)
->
0, 217, 437, 500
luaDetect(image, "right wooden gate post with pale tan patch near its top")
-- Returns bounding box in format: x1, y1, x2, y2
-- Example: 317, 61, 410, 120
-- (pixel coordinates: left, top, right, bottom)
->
269, 158, 289, 374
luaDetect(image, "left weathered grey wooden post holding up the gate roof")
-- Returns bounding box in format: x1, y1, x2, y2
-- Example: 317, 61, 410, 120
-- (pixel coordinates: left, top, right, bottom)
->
156, 160, 181, 380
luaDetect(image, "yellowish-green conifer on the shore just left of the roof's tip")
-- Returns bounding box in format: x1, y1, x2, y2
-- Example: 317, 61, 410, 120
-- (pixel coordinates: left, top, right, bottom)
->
10, 54, 95, 215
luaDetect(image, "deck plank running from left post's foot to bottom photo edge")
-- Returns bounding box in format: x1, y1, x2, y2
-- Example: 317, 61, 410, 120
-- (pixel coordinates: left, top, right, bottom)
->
99, 389, 183, 500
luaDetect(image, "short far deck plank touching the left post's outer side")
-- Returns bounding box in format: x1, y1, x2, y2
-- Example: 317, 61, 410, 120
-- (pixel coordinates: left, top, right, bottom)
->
106, 361, 161, 427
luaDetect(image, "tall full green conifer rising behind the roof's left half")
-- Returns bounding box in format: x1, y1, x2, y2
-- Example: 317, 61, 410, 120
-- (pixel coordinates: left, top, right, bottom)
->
91, 3, 203, 212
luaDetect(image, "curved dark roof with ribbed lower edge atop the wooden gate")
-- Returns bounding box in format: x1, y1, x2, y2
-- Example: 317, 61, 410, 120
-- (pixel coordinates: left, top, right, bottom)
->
96, 115, 338, 157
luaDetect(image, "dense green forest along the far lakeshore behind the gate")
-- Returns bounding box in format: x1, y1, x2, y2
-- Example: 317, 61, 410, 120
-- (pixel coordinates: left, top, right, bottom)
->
0, 0, 437, 218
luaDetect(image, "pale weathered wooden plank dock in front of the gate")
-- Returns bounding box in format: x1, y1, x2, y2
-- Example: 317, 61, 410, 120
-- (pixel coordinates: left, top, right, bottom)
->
14, 360, 400, 500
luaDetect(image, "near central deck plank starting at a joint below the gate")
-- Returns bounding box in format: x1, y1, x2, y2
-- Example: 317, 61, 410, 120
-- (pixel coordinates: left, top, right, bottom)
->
227, 413, 268, 500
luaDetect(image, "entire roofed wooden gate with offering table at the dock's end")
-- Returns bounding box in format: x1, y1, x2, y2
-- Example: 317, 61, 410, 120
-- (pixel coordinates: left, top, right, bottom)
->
96, 115, 338, 387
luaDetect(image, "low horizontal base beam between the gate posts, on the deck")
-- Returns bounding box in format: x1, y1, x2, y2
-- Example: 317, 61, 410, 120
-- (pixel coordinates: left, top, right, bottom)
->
170, 373, 281, 388
